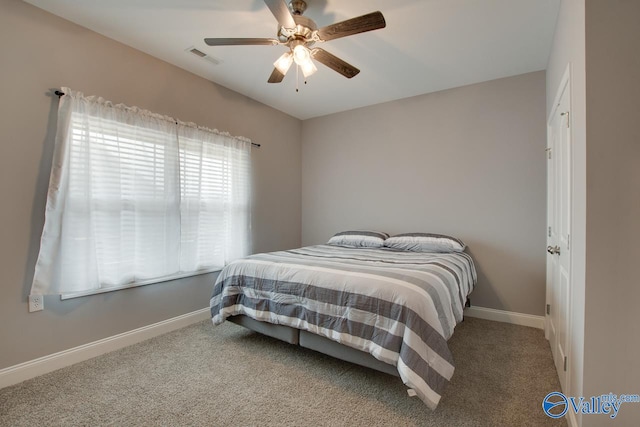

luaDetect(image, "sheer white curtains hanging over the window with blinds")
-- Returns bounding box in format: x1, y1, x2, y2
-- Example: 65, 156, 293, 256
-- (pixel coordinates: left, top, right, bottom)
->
31, 88, 251, 295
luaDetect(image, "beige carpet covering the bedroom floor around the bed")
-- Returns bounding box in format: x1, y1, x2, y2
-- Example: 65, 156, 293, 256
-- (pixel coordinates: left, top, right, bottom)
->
0, 318, 566, 426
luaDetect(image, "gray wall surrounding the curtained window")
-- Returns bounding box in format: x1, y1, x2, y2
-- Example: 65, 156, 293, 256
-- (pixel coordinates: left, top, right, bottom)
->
0, 0, 301, 369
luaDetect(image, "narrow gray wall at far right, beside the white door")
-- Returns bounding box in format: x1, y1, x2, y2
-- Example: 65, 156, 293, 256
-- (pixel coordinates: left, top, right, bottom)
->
583, 0, 640, 426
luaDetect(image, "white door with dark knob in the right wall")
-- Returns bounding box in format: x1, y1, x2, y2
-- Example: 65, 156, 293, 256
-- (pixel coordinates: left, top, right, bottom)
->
546, 78, 571, 391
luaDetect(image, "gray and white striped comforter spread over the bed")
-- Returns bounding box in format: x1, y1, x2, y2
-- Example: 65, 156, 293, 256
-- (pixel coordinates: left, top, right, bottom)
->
210, 245, 476, 409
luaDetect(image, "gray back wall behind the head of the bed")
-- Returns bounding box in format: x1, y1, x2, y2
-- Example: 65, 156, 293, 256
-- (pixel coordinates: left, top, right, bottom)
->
302, 71, 546, 315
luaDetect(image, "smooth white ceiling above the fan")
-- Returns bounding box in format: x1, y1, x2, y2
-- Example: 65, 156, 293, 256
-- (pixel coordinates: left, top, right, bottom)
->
25, 0, 560, 119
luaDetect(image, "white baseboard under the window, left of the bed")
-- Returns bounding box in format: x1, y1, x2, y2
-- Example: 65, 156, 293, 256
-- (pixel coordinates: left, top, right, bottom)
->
0, 308, 211, 388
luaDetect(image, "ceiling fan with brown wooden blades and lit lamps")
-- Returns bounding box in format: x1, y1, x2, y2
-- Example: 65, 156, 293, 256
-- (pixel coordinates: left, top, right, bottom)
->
204, 0, 386, 83
